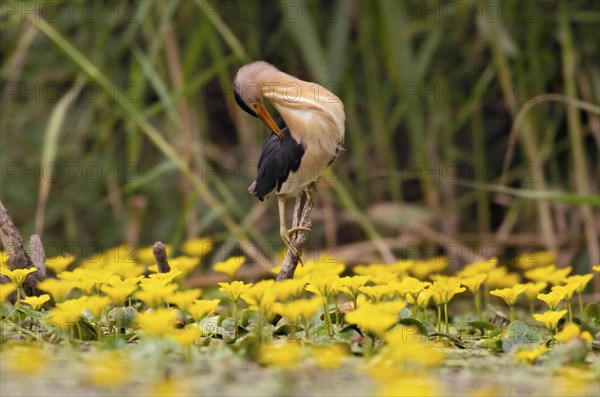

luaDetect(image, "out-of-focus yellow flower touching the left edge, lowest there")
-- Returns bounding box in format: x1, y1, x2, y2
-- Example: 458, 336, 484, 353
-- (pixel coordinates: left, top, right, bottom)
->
2, 343, 49, 375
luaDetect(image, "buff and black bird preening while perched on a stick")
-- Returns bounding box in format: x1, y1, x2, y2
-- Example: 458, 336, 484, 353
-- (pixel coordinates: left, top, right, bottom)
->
233, 61, 346, 263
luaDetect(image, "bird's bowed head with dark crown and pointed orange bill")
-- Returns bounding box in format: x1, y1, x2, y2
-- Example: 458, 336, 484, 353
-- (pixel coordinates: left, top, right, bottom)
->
233, 61, 283, 138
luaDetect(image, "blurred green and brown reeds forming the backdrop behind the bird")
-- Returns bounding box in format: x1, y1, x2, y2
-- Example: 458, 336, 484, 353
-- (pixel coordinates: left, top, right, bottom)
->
0, 0, 600, 272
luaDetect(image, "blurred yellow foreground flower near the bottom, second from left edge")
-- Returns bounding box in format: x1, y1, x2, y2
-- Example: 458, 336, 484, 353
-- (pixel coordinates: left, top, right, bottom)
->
85, 350, 129, 389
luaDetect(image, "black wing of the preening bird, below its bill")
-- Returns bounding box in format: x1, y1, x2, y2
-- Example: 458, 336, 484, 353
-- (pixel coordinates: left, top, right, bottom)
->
249, 118, 306, 201
